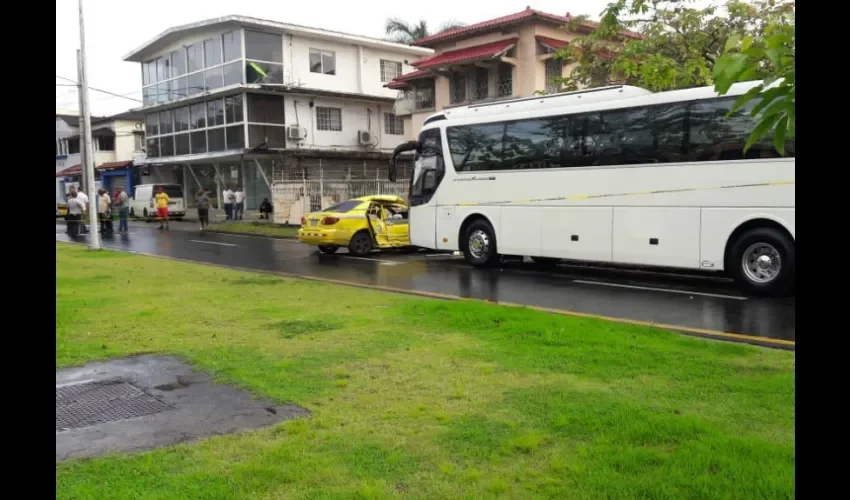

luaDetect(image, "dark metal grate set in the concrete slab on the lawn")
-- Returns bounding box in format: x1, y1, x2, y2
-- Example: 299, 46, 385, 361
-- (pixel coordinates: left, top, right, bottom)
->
56, 380, 171, 431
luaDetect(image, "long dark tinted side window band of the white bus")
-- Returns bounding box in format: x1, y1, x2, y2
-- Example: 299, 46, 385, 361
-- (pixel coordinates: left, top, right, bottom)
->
446, 97, 794, 172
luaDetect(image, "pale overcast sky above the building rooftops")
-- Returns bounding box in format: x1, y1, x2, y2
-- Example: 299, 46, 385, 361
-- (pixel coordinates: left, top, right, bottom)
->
56, 0, 628, 116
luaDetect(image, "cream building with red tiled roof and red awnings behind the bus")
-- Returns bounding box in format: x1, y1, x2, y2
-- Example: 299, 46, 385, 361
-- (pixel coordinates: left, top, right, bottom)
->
386, 7, 640, 139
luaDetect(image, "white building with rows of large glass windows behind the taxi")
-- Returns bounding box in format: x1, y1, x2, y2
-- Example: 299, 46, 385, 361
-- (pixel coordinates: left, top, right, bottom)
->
124, 15, 433, 209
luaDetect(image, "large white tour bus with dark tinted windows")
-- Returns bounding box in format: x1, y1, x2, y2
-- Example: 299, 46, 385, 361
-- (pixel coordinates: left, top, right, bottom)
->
390, 82, 796, 294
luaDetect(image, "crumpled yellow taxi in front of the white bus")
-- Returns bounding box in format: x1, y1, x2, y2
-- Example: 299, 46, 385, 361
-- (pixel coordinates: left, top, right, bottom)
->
298, 195, 411, 255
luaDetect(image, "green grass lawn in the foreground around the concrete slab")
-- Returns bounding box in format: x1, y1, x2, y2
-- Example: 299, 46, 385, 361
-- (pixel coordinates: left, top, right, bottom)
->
56, 243, 795, 500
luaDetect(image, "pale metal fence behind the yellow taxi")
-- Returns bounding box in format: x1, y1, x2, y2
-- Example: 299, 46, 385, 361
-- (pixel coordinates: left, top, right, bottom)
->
272, 179, 410, 224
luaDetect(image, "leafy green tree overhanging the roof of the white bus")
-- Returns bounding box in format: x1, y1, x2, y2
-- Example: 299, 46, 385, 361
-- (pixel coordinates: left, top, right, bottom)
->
544, 0, 795, 151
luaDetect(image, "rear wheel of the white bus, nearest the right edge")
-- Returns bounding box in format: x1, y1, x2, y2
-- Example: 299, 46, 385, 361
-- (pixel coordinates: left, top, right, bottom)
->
726, 227, 797, 296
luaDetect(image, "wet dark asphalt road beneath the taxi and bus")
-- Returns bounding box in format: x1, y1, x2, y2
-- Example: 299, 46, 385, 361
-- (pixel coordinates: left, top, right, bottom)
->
56, 224, 796, 348
